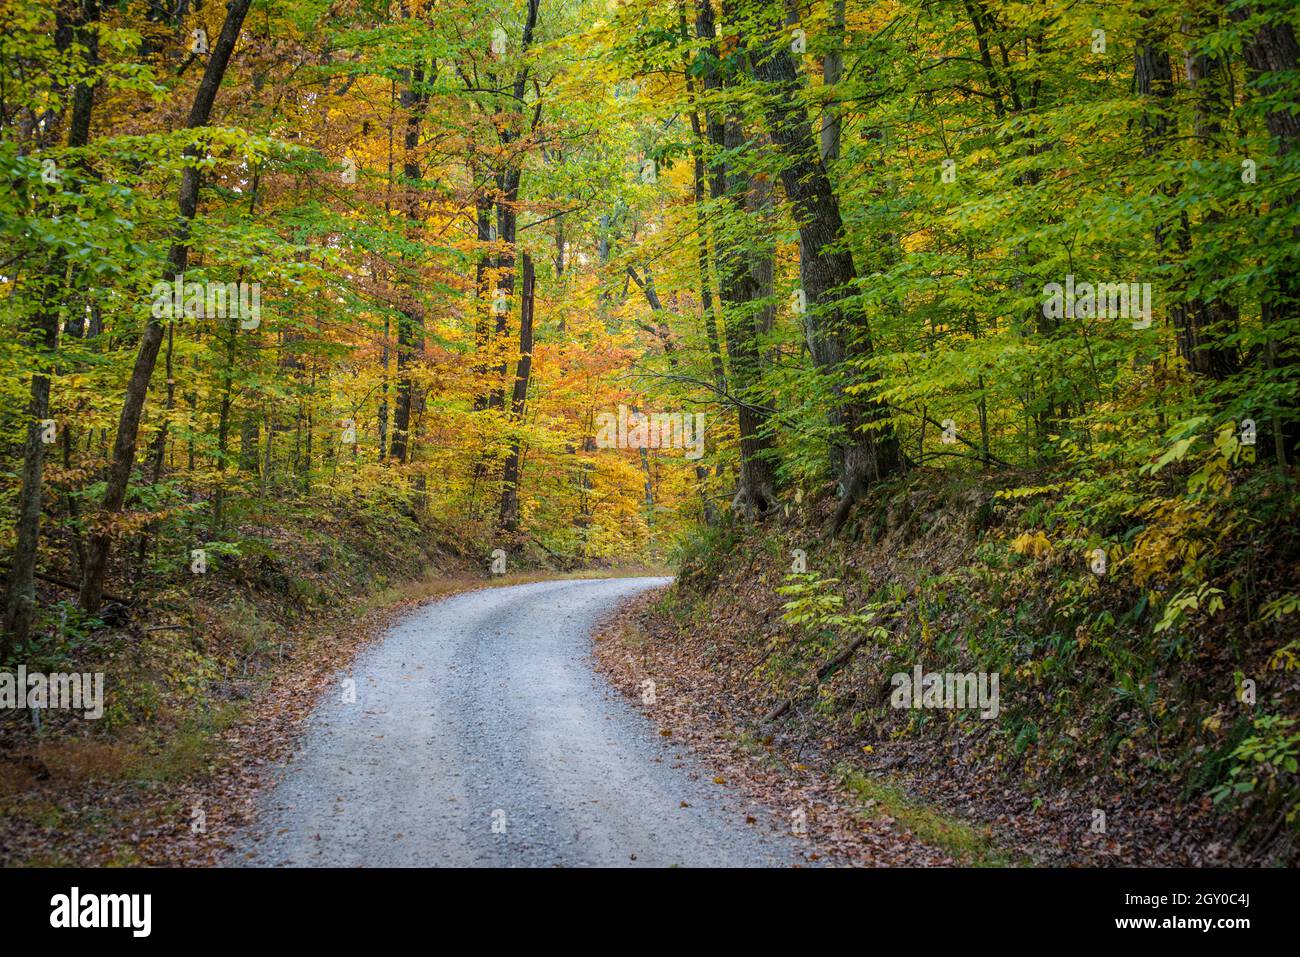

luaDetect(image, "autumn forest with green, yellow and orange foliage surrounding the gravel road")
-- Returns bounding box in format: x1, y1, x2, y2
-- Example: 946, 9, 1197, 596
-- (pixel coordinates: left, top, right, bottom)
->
0, 0, 1300, 865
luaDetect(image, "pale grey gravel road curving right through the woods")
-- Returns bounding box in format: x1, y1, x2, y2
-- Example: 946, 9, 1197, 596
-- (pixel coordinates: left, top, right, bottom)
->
229, 579, 802, 867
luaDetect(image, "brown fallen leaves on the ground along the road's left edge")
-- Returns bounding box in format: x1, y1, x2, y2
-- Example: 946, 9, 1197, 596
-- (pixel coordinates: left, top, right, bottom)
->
0, 573, 512, 866
